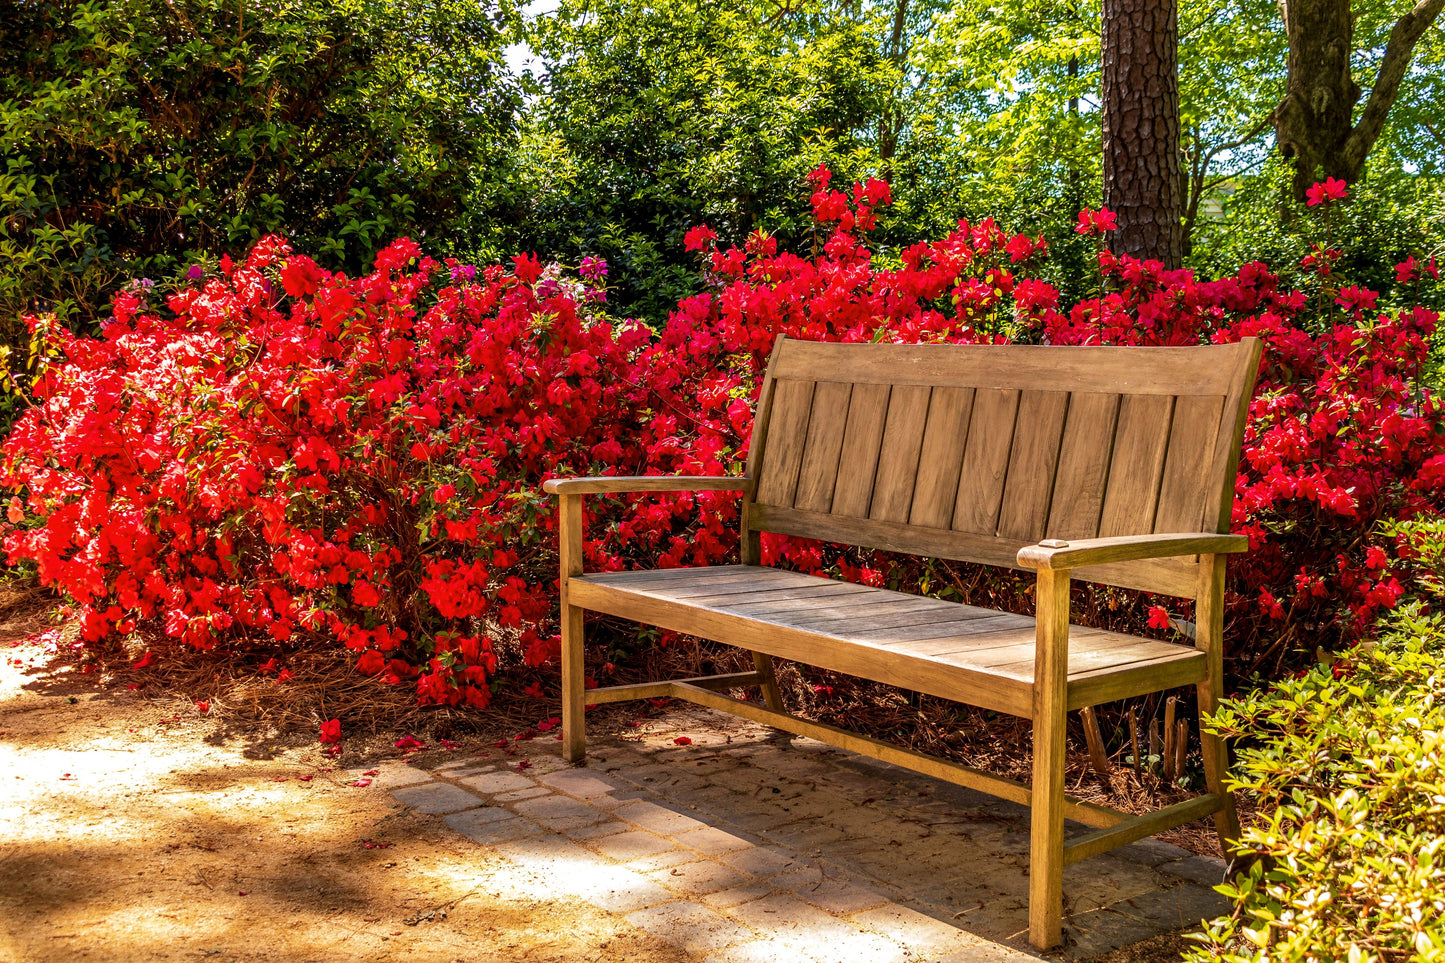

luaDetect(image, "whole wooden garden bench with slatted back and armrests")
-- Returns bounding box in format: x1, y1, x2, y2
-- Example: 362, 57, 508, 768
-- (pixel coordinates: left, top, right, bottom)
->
545, 338, 1260, 949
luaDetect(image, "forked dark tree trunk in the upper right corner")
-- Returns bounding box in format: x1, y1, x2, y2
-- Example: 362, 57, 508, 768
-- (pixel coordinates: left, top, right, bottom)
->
1274, 0, 1445, 201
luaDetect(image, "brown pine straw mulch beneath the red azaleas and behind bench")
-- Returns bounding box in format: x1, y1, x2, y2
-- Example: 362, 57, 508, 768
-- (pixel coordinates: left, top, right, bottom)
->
0, 580, 1253, 855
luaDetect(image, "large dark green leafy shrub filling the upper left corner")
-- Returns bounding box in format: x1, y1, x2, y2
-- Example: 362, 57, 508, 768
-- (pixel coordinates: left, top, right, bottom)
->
0, 0, 520, 336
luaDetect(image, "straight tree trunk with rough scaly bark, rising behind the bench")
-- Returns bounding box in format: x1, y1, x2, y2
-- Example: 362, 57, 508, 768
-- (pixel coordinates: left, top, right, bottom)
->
1103, 0, 1183, 268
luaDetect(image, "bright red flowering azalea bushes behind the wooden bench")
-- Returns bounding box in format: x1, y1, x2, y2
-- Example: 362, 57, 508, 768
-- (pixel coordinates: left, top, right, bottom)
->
3, 161, 1445, 696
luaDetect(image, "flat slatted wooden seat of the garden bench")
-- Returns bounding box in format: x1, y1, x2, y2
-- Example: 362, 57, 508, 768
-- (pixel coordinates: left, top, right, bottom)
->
569, 565, 1205, 717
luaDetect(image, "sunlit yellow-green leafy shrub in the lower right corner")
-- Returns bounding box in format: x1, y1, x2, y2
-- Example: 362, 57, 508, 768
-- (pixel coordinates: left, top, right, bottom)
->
1186, 584, 1445, 963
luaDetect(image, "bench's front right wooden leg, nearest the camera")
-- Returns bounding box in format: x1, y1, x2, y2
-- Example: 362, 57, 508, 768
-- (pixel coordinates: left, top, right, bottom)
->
1029, 568, 1069, 950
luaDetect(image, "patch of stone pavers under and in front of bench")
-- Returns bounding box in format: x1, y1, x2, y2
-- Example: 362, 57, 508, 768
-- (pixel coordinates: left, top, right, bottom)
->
355, 710, 1225, 963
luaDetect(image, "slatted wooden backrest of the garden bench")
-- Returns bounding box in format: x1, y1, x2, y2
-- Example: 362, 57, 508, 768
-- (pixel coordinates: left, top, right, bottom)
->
744, 338, 1260, 596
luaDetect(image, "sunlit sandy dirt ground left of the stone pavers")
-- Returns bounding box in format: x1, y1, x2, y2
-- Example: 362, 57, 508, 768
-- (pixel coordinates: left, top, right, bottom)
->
0, 610, 689, 963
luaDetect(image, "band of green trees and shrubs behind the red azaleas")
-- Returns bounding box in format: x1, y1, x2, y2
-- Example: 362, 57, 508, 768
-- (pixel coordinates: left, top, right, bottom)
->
0, 0, 1445, 328
